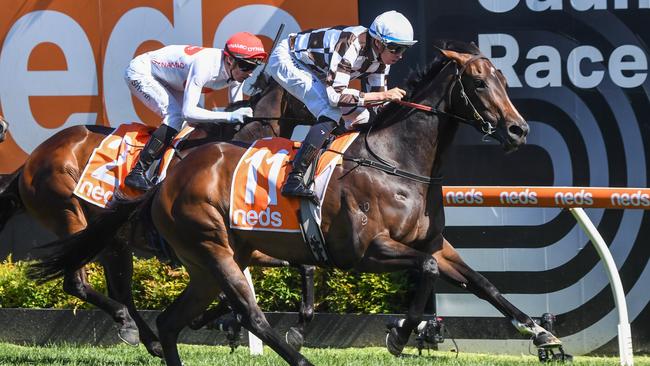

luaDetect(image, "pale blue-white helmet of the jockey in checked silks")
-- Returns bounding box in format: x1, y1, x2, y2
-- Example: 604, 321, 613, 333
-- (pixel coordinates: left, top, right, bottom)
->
368, 10, 418, 46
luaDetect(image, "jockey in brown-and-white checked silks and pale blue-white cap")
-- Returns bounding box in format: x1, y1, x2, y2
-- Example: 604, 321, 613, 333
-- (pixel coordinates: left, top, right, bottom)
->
267, 11, 417, 197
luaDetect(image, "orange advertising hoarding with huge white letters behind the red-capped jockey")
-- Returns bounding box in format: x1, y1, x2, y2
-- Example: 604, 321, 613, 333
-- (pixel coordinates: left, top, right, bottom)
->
0, 0, 358, 174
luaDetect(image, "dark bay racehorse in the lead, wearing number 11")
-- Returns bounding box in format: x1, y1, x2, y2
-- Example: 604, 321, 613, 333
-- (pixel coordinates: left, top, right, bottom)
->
27, 42, 561, 365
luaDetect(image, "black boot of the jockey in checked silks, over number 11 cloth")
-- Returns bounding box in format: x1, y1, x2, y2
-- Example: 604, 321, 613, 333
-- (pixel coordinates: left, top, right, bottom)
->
281, 116, 337, 200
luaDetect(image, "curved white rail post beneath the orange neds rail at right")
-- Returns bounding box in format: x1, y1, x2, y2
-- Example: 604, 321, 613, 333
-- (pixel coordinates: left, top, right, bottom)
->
569, 207, 634, 366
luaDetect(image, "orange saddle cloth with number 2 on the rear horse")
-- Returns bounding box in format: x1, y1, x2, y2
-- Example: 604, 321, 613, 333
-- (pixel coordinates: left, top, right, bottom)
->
74, 122, 194, 208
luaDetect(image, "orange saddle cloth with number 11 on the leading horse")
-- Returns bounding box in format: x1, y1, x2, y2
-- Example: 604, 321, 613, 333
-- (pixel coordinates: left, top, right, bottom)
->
229, 132, 359, 232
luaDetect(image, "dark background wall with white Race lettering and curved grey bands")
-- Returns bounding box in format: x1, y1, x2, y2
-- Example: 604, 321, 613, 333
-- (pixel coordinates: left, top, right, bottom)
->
359, 0, 650, 352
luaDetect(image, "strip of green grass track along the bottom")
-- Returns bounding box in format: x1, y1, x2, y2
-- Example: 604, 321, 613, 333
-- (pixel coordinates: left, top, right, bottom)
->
0, 343, 650, 366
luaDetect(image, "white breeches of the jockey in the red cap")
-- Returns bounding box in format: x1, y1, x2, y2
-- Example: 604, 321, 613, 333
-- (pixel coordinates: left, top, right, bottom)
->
124, 55, 183, 131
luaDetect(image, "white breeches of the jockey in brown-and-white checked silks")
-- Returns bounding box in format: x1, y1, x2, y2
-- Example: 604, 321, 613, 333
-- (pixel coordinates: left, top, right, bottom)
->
266, 39, 370, 129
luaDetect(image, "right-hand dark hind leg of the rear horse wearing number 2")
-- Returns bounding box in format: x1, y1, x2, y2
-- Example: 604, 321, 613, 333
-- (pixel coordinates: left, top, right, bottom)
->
99, 240, 162, 357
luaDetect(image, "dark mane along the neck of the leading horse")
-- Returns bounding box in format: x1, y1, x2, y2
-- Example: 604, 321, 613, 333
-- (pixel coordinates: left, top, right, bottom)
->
368, 40, 481, 127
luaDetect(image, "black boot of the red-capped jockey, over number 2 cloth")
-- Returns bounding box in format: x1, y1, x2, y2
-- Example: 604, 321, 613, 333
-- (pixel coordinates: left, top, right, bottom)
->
124, 125, 178, 191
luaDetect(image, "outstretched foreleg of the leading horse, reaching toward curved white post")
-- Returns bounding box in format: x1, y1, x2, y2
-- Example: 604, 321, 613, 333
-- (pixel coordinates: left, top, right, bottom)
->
434, 239, 562, 347
